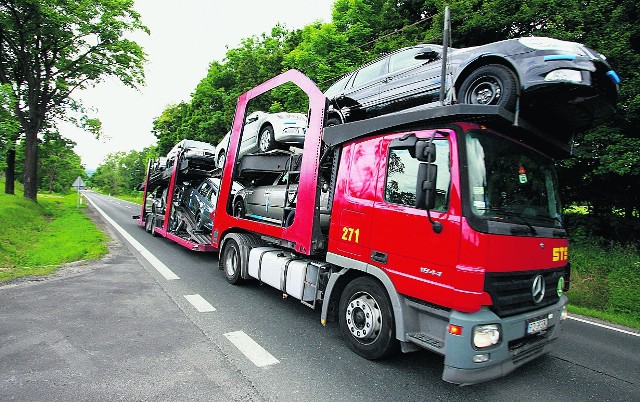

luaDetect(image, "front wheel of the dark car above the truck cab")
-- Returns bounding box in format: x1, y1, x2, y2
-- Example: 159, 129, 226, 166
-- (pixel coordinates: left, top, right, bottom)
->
458, 64, 517, 112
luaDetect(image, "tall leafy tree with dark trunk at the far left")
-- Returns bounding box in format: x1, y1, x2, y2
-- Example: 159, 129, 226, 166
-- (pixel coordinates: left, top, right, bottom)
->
0, 0, 148, 201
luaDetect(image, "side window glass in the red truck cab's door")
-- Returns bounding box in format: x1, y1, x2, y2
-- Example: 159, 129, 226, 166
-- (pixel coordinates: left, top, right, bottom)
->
384, 140, 451, 212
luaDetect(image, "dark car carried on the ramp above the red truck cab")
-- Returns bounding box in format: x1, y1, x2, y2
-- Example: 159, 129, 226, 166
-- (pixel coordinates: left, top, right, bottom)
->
325, 37, 620, 131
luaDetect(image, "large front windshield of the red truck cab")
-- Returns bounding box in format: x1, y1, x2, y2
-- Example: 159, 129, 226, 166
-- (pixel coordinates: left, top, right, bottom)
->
465, 131, 562, 231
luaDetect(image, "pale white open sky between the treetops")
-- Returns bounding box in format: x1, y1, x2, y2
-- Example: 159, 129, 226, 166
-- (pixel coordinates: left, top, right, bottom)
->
58, 0, 334, 170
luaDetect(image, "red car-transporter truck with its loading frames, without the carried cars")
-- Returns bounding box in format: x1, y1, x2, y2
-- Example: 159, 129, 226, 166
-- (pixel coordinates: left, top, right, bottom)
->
138, 70, 570, 384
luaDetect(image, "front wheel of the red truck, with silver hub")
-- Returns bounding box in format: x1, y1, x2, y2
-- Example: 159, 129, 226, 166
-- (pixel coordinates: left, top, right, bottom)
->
339, 276, 398, 360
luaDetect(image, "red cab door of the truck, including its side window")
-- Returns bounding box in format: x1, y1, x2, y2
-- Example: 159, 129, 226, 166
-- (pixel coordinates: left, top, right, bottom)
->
369, 131, 461, 300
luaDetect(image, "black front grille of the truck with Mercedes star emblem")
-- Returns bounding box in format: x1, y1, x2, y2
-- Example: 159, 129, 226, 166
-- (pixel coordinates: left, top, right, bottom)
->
484, 268, 565, 317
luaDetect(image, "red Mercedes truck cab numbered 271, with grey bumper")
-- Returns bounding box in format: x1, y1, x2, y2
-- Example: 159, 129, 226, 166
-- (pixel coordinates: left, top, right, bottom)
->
326, 118, 568, 383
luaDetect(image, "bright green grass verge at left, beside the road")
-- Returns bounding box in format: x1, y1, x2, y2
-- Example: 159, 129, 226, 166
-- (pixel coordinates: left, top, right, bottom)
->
0, 179, 108, 282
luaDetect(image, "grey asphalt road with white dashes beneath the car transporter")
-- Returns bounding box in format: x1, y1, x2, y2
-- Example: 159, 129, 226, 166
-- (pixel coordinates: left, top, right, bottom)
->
0, 193, 640, 401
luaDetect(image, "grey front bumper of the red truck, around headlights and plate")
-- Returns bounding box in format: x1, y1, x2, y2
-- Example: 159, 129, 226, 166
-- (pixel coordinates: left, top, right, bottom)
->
442, 295, 568, 385
